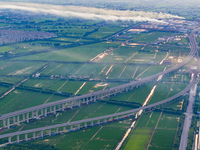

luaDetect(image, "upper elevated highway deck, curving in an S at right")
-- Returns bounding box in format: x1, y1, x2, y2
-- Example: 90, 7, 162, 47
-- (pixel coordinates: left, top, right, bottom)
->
0, 28, 200, 120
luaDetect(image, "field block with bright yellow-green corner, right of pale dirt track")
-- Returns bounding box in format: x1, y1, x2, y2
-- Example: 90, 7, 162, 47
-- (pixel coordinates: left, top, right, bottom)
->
124, 111, 179, 150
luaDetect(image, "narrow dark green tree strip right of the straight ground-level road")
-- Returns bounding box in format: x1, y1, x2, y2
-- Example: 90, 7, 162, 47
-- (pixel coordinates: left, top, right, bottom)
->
187, 116, 197, 150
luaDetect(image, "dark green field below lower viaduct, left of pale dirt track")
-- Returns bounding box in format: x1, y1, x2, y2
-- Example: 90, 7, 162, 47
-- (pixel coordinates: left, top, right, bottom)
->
29, 126, 126, 150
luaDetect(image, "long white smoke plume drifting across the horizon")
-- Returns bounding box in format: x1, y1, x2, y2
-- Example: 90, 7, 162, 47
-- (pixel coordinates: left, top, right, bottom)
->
0, 2, 183, 22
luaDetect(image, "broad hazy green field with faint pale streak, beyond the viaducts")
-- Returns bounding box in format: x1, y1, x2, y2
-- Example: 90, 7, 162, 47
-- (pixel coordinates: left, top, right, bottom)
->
15, 43, 117, 62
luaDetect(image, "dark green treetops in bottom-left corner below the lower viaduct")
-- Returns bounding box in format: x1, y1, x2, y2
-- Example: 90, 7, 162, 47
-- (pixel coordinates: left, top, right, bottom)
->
1, 143, 59, 150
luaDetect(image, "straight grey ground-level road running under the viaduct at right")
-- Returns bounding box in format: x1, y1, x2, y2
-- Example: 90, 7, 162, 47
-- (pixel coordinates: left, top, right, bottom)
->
179, 74, 197, 150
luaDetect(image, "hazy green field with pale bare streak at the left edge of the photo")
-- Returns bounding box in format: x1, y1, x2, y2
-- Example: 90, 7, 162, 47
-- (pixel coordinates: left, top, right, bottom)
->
0, 62, 45, 75
